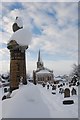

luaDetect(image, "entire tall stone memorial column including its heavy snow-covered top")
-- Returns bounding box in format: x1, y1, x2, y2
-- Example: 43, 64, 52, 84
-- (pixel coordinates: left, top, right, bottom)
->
7, 17, 32, 91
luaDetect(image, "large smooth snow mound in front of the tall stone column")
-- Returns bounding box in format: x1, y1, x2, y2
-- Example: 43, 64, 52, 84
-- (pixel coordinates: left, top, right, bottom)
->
2, 84, 50, 118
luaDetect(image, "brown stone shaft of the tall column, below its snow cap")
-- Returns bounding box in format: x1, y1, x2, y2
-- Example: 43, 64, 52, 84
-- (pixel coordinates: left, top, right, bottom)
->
7, 40, 28, 91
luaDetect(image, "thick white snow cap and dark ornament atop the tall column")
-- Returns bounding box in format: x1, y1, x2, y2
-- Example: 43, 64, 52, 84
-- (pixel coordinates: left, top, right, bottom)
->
9, 17, 32, 46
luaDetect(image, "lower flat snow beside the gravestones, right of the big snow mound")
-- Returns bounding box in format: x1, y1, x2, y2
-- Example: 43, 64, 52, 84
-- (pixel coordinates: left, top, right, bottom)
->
38, 85, 78, 118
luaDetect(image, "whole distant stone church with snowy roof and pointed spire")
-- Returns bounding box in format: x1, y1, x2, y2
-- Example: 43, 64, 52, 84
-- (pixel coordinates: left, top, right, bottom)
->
33, 50, 54, 84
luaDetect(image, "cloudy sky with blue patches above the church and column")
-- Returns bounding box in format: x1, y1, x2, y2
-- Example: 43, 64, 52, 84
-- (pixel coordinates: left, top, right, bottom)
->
0, 2, 78, 75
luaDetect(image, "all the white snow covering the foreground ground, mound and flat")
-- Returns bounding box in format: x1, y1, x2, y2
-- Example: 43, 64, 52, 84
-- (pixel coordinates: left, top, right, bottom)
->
2, 83, 78, 118
